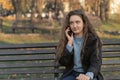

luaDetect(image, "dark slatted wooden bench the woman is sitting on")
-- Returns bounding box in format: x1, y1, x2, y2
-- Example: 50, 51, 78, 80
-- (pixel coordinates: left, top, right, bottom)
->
0, 40, 120, 80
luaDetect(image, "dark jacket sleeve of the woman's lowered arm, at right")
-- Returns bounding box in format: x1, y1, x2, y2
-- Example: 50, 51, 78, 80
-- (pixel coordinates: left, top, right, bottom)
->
88, 39, 102, 75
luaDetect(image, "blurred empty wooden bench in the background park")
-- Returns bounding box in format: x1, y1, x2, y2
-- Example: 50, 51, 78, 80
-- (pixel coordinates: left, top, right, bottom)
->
11, 19, 56, 34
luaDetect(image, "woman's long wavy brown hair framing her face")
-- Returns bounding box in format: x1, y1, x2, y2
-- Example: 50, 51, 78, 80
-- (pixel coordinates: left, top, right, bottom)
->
56, 10, 97, 61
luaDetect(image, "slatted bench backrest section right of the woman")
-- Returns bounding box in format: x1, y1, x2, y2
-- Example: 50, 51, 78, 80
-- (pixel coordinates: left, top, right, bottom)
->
102, 40, 120, 80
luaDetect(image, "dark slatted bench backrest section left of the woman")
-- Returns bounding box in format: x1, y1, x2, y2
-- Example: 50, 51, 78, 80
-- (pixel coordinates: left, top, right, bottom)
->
0, 43, 56, 80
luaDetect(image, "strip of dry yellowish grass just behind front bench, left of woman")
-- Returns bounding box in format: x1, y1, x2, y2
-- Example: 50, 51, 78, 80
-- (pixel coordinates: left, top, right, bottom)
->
0, 33, 58, 44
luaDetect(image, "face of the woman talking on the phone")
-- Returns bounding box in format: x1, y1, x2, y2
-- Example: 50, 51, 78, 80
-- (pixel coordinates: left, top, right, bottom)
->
70, 15, 84, 37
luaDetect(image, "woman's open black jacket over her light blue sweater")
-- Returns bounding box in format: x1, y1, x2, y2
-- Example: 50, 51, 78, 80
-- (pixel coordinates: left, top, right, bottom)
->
59, 35, 104, 80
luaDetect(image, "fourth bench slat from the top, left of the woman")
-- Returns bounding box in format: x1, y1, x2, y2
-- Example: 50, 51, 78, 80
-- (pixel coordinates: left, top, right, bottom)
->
0, 61, 55, 69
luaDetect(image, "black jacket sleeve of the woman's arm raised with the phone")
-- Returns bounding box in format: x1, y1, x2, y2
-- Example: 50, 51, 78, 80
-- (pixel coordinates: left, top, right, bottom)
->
59, 48, 73, 66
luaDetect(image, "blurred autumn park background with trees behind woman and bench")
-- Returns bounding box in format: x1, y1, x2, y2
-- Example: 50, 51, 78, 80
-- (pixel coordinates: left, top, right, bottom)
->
0, 0, 120, 44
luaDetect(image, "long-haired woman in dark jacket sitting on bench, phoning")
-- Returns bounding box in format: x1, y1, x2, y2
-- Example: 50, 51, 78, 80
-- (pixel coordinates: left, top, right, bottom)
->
57, 10, 104, 80
